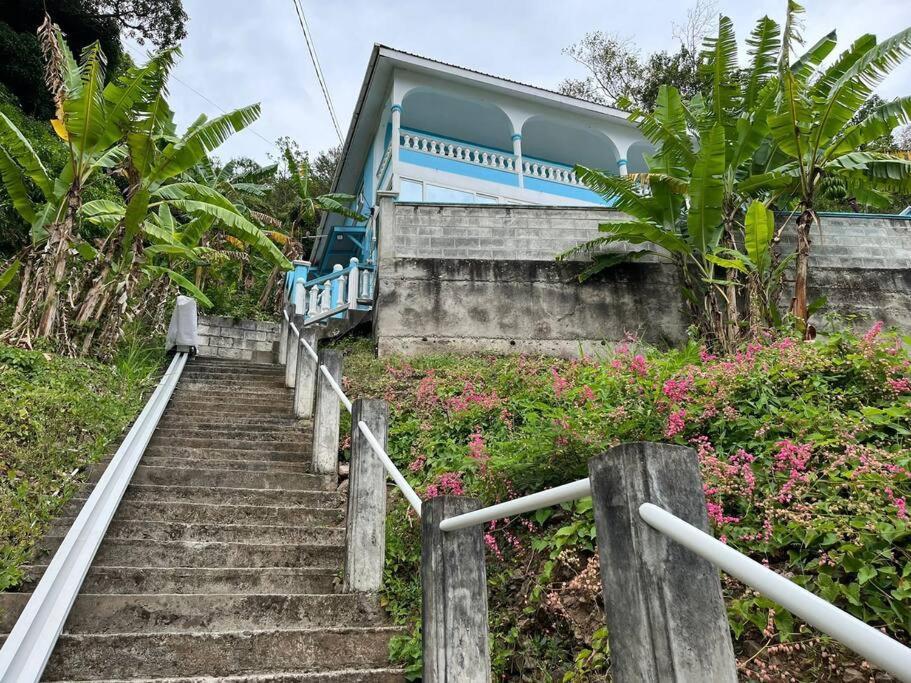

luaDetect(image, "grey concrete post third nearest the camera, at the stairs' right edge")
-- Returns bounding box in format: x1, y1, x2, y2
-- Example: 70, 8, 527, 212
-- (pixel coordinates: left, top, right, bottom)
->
345, 398, 389, 593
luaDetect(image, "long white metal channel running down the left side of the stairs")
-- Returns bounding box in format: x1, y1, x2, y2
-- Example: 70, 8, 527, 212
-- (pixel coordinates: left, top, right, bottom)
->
0, 353, 187, 683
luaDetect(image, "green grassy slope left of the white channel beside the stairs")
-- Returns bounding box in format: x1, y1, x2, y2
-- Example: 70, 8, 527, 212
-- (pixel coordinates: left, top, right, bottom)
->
0, 341, 161, 590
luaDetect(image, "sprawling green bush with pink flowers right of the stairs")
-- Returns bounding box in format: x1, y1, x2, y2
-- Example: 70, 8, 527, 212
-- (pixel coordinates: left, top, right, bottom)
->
336, 325, 911, 680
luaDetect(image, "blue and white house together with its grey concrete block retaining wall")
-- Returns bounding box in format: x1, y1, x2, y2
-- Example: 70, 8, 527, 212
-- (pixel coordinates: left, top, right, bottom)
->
286, 45, 911, 356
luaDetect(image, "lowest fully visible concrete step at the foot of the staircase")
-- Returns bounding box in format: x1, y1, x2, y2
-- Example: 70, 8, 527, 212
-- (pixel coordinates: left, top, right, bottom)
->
38, 627, 402, 680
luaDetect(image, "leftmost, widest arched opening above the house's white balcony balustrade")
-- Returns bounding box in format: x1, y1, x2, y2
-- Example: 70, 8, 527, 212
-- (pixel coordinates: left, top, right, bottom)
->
401, 88, 512, 152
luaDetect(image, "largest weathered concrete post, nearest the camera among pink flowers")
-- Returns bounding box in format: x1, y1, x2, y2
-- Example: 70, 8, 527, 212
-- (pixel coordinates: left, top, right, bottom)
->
588, 443, 737, 683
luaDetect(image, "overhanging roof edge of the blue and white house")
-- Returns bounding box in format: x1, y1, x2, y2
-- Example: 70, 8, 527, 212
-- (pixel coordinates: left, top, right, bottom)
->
311, 43, 632, 262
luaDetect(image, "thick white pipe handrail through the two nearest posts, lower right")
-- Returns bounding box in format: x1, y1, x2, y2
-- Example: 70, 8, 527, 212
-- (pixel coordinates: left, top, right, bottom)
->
440, 479, 911, 681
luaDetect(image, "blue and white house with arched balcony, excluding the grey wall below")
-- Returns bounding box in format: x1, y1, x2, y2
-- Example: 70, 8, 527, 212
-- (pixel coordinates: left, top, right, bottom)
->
312, 45, 650, 275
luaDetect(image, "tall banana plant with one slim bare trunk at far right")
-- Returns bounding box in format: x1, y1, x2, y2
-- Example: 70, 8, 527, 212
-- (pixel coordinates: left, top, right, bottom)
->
768, 0, 911, 332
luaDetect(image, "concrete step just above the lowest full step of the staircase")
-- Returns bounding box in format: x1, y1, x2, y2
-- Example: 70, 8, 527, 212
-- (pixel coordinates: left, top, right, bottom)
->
0, 592, 385, 634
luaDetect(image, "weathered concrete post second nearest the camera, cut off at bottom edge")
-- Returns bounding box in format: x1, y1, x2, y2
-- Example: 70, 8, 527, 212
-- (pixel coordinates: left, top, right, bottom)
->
421, 496, 490, 683
